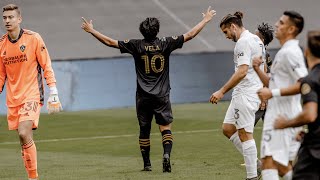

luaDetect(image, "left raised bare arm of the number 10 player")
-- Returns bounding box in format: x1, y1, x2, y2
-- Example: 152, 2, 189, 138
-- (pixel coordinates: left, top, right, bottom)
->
81, 17, 119, 48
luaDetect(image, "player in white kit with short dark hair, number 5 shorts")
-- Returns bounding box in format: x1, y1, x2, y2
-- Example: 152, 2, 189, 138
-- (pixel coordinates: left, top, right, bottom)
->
254, 11, 308, 180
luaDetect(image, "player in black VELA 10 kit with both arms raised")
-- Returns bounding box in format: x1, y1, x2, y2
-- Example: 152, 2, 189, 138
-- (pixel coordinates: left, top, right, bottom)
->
81, 7, 216, 172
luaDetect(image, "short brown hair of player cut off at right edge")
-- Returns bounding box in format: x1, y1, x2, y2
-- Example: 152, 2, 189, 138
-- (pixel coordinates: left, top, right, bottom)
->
308, 30, 320, 58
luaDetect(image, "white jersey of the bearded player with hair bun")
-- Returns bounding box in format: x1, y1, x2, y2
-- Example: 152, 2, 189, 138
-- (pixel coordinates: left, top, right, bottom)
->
232, 30, 265, 102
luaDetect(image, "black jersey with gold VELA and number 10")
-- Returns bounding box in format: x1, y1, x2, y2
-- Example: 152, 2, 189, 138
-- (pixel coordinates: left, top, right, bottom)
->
119, 35, 184, 97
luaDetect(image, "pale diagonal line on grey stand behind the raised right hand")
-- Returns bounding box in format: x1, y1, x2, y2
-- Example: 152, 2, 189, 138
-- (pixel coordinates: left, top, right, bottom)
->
153, 0, 216, 52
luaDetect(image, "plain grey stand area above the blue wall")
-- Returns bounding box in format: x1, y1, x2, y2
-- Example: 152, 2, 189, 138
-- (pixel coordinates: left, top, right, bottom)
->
0, 0, 320, 60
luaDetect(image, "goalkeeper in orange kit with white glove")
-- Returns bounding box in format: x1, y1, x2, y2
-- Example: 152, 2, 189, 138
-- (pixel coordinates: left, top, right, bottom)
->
0, 4, 62, 180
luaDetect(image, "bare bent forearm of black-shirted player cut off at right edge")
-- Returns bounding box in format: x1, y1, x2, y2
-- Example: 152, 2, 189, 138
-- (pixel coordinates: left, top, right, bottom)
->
274, 102, 318, 129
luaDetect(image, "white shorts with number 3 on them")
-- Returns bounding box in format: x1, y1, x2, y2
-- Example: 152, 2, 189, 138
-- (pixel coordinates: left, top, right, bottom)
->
223, 95, 259, 133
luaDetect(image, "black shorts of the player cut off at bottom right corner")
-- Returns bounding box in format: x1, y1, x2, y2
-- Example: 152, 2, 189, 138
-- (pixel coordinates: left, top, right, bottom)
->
292, 145, 320, 180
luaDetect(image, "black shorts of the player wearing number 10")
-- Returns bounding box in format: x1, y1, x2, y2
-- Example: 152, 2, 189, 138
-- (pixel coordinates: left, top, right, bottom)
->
136, 93, 173, 126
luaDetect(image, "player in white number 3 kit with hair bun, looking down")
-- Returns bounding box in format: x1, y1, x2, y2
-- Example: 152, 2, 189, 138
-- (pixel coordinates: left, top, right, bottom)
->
210, 12, 265, 180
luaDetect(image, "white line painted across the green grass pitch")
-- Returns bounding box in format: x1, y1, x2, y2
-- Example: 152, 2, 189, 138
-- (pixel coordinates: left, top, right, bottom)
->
0, 127, 261, 145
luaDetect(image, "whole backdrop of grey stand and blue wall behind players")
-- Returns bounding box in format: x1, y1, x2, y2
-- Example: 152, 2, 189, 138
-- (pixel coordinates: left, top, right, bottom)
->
0, 0, 320, 114
